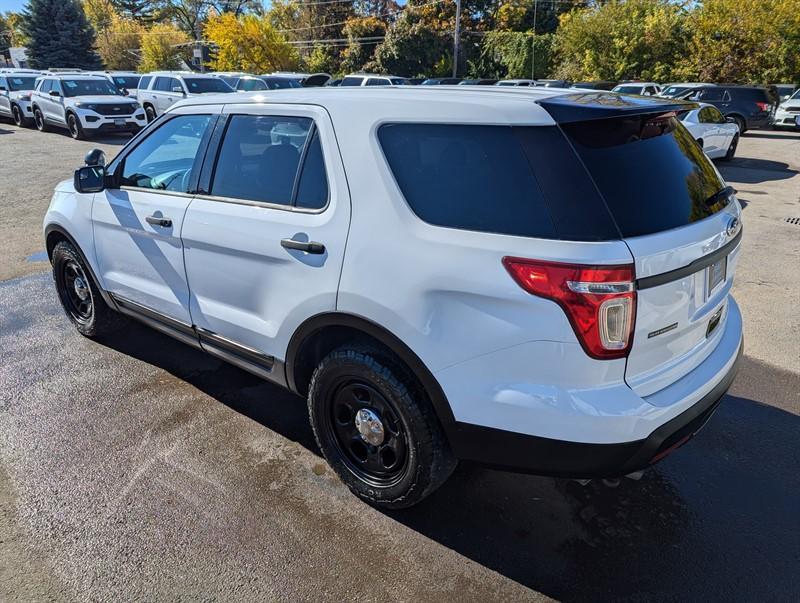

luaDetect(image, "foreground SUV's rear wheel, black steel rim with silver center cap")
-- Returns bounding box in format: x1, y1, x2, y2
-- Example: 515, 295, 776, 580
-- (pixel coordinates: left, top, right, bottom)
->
308, 347, 457, 509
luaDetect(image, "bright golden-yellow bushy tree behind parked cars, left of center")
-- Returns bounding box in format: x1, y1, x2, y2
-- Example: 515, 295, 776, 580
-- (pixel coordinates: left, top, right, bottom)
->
204, 13, 298, 73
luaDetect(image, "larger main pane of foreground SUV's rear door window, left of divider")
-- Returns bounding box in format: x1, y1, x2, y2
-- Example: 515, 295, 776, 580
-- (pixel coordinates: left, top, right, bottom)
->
211, 115, 312, 205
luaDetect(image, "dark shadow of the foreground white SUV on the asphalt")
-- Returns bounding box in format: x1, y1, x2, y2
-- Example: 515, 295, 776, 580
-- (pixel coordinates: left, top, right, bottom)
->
97, 324, 800, 601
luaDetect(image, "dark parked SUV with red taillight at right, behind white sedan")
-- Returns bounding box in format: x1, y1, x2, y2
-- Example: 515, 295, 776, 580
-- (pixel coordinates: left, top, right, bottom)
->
680, 84, 778, 133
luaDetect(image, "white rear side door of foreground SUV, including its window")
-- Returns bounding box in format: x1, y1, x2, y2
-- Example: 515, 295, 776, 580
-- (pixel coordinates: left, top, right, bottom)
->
182, 104, 350, 371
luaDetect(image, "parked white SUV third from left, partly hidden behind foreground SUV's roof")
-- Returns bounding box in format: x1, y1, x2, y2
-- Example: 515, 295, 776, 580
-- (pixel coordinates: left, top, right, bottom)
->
136, 71, 235, 121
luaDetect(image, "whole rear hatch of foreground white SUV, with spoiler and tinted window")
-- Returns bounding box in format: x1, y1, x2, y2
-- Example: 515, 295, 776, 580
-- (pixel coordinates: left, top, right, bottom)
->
541, 95, 741, 396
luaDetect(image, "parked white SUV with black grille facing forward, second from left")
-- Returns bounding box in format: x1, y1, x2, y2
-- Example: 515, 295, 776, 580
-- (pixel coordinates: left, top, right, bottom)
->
31, 74, 147, 139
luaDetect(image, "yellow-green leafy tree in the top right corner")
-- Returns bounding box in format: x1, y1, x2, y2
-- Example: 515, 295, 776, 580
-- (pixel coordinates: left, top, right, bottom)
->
680, 0, 800, 83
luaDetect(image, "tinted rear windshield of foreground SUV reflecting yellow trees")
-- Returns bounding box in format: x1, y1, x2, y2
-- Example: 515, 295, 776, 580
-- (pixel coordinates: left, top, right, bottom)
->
562, 115, 723, 237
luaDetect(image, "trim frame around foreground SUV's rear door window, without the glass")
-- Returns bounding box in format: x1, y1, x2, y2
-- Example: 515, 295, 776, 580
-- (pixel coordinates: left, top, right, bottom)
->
196, 113, 331, 214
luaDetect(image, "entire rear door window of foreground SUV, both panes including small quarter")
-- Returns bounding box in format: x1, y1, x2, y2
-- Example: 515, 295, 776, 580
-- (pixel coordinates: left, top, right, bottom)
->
211, 115, 328, 208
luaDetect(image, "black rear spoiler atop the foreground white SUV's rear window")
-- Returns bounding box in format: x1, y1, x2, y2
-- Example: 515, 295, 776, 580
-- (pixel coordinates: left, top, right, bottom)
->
536, 92, 700, 124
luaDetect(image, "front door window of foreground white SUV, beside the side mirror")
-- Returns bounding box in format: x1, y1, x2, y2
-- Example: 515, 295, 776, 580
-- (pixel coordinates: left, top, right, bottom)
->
120, 115, 212, 193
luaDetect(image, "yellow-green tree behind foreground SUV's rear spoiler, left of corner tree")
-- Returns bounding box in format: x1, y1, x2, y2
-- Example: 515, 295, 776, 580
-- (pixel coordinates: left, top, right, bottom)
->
555, 0, 687, 81
